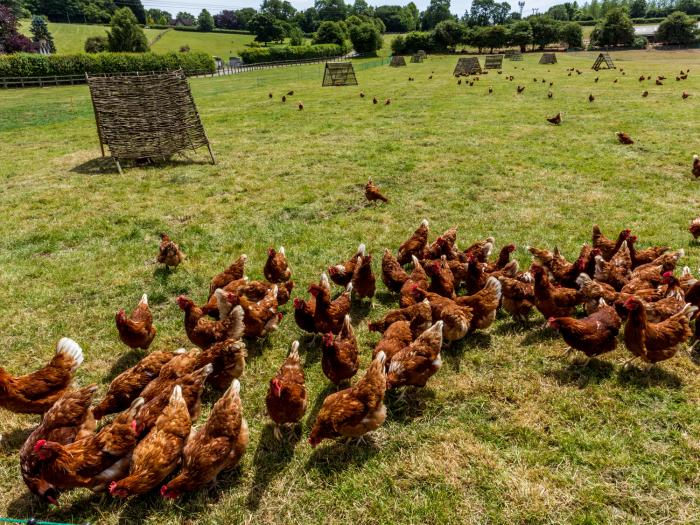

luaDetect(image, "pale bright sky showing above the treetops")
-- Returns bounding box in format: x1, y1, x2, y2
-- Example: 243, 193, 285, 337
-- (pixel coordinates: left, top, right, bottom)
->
142, 0, 563, 16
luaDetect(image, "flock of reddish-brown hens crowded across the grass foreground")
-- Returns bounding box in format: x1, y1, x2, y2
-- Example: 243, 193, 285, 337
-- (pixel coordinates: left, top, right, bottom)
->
0, 63, 700, 510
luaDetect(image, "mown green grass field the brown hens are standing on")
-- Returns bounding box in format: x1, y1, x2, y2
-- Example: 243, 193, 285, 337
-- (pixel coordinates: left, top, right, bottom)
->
0, 51, 700, 525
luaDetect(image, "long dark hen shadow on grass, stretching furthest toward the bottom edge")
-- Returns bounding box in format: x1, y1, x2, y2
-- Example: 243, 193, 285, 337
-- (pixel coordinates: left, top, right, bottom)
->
246, 424, 301, 511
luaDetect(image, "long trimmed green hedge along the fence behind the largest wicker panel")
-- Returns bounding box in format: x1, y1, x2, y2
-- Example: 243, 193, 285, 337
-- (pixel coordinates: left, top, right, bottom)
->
0, 52, 216, 77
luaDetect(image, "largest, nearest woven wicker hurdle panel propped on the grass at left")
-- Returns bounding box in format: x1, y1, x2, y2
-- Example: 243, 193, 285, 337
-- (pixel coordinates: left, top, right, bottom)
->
86, 70, 215, 173
